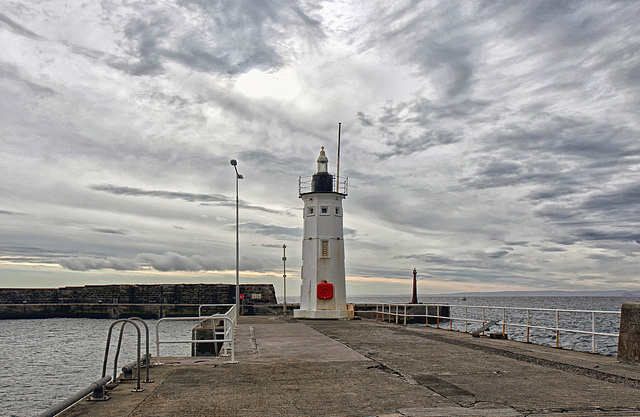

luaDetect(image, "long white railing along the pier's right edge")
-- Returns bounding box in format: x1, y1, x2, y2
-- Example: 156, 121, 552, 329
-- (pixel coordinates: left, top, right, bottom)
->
364, 303, 620, 353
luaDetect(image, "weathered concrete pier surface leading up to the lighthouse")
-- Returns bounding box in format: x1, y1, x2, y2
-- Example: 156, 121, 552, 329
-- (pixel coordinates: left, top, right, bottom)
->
60, 317, 640, 417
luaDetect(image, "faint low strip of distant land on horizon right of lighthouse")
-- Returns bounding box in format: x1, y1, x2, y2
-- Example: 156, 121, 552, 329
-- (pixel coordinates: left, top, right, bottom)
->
352, 290, 640, 298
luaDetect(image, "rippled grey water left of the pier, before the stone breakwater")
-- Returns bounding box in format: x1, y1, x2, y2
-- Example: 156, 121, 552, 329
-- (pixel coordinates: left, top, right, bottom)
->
0, 318, 194, 417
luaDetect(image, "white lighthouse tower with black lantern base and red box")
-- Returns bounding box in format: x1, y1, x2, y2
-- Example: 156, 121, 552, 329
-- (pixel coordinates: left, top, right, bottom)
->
293, 147, 354, 319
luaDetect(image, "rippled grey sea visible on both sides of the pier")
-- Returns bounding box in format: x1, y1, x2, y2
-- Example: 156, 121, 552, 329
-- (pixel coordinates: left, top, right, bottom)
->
0, 297, 640, 417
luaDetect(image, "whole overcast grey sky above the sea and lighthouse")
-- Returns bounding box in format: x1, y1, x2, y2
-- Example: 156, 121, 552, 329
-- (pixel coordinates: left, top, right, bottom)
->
0, 0, 640, 296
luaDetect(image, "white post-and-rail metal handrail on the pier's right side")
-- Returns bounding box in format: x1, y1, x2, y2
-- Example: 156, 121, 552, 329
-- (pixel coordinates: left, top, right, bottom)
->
364, 303, 620, 353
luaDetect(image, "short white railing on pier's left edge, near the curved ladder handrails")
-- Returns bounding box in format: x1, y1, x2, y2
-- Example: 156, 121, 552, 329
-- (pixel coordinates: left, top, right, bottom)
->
156, 304, 238, 363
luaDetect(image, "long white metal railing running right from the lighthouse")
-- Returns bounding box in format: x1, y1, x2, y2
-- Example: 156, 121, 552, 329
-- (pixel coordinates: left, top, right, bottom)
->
364, 303, 620, 354
